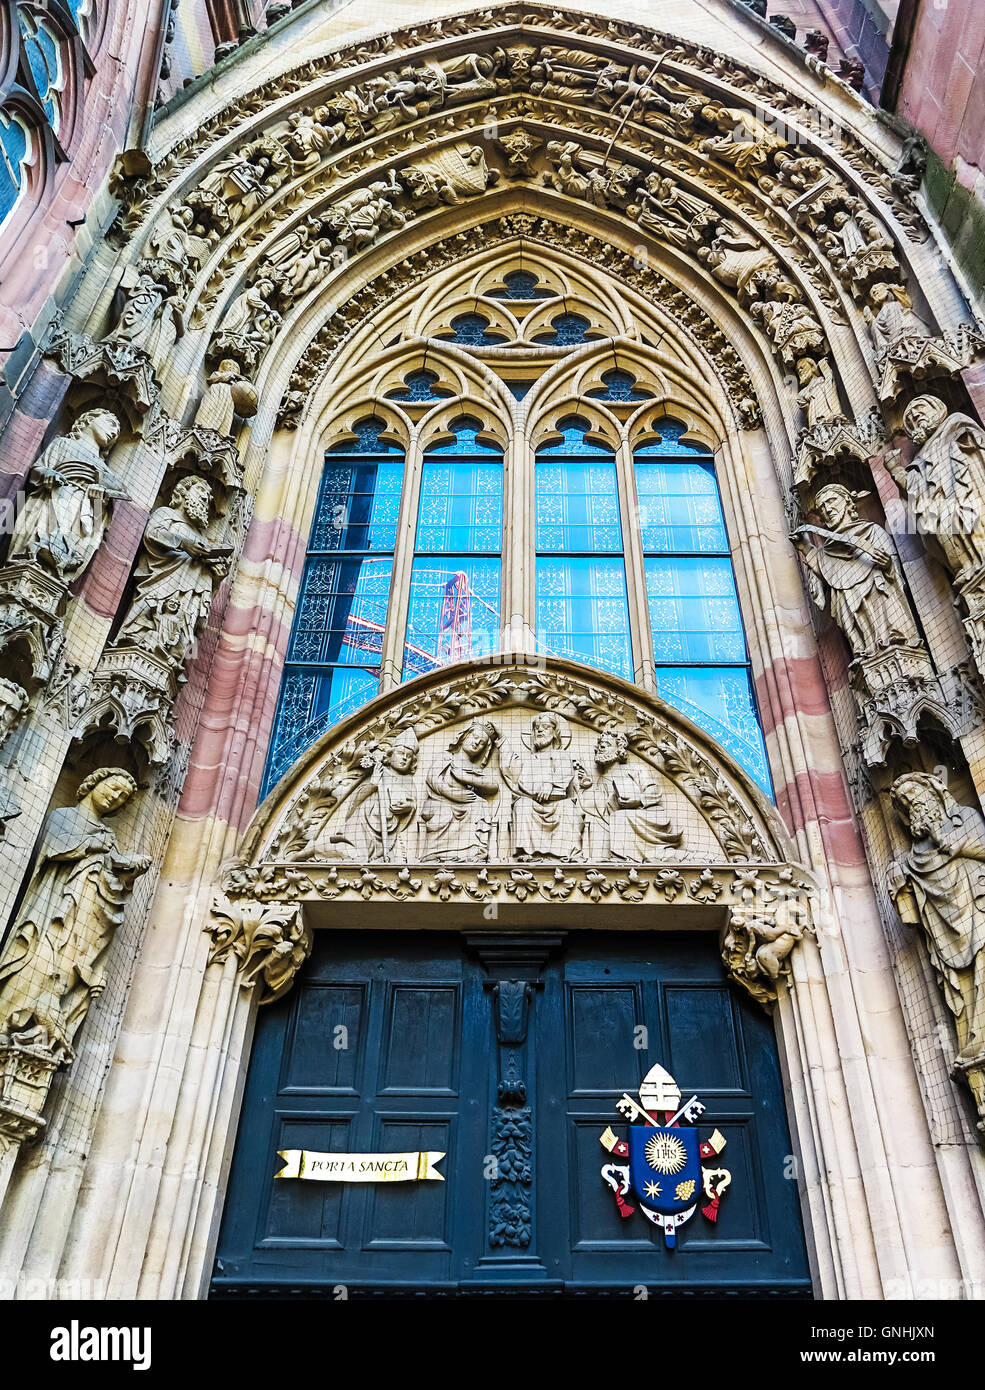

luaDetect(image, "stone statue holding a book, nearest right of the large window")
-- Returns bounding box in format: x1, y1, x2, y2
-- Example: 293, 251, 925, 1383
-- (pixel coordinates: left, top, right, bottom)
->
795, 482, 922, 656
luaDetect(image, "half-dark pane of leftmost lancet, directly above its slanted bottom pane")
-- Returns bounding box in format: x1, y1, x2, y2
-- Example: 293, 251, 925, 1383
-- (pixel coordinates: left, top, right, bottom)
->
288, 556, 393, 666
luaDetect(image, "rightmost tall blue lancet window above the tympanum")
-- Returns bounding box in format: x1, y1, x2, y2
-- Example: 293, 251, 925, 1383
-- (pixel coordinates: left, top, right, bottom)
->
635, 421, 772, 795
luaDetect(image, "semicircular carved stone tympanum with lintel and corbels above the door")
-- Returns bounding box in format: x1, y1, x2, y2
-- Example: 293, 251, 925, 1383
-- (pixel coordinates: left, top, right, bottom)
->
208, 656, 814, 1005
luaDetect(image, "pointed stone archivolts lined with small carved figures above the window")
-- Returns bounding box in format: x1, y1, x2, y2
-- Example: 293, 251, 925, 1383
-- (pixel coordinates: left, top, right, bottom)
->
94, 7, 978, 444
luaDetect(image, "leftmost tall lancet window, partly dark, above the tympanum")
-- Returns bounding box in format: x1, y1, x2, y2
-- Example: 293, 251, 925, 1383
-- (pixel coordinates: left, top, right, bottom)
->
264, 420, 403, 794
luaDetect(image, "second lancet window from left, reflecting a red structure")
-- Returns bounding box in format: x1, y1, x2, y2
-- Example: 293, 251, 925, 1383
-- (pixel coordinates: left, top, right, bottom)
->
403, 418, 503, 680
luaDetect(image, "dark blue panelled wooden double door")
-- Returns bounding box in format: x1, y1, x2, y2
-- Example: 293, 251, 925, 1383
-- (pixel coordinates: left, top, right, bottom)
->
213, 930, 810, 1297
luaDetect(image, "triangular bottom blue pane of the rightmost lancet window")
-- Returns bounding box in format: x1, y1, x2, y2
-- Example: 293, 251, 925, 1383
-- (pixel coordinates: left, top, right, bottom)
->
657, 666, 772, 796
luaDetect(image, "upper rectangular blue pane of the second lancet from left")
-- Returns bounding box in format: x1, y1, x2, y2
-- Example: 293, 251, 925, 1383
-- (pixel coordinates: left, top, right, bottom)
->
417, 459, 503, 555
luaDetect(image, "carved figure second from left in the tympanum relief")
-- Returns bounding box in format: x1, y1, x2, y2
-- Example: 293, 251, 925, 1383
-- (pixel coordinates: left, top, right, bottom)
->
421, 719, 500, 863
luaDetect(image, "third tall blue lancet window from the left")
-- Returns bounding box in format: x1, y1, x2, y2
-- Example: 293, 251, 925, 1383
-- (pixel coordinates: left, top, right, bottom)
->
536, 420, 632, 680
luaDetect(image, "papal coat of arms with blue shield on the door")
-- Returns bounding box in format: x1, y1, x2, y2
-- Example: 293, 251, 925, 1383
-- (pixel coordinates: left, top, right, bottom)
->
600, 1066, 732, 1250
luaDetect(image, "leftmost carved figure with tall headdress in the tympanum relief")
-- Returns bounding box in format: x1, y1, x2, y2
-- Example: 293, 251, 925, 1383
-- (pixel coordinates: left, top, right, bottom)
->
338, 728, 418, 863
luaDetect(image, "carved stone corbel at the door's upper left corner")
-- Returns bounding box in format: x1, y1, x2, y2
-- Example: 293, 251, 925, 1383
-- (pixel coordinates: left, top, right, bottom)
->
206, 897, 314, 1004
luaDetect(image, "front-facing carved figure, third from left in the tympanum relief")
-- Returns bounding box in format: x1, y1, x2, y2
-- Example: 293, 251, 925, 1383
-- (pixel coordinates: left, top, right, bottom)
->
502, 712, 582, 863
